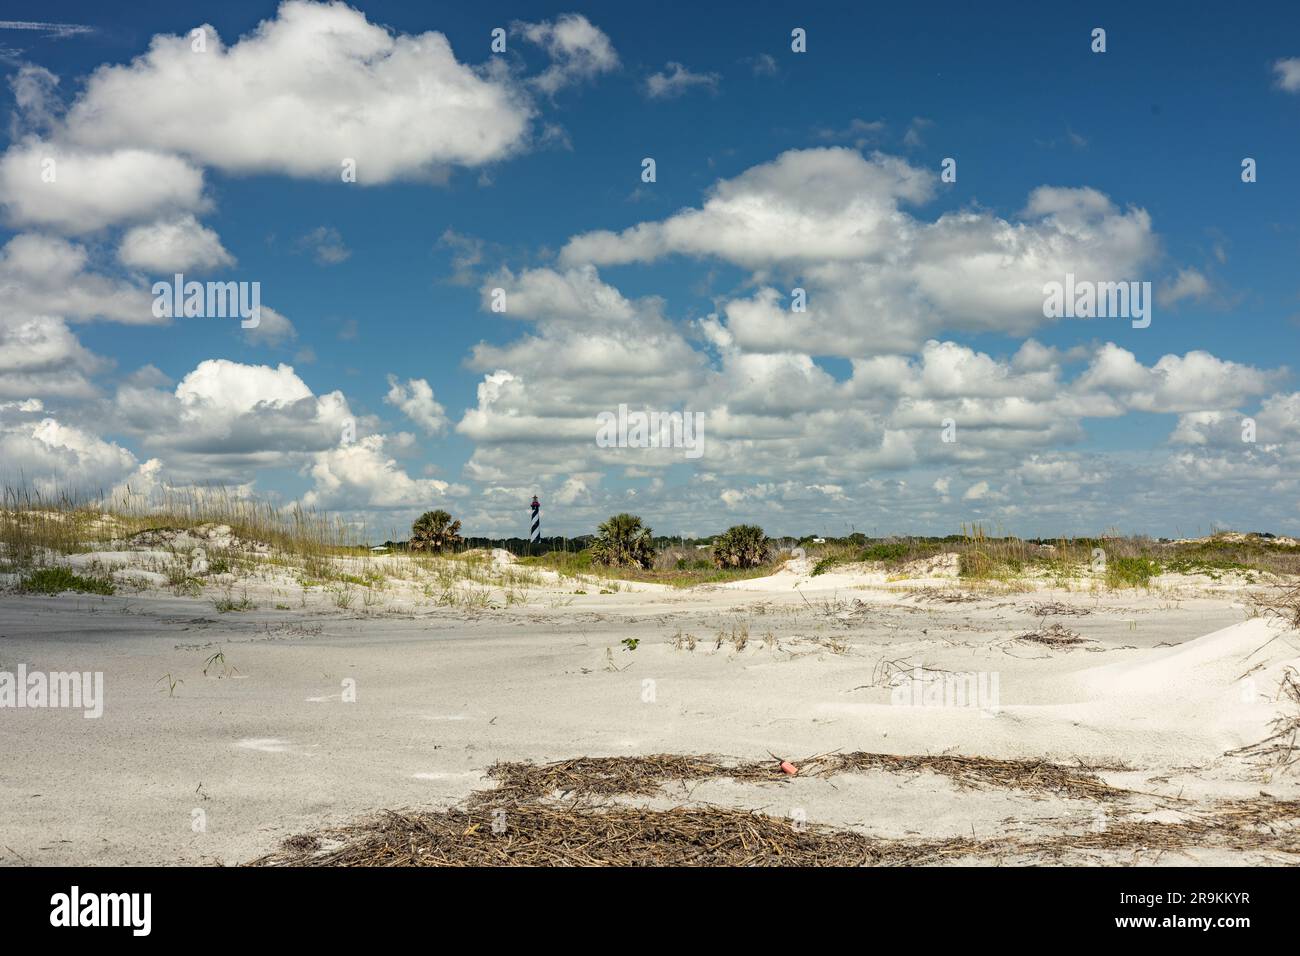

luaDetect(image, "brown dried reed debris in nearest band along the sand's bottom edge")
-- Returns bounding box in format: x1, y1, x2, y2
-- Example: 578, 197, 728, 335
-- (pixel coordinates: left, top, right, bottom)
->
250, 797, 1300, 866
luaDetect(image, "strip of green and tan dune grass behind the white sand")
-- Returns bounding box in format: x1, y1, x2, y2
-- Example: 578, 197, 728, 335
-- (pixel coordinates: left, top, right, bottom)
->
0, 485, 1300, 606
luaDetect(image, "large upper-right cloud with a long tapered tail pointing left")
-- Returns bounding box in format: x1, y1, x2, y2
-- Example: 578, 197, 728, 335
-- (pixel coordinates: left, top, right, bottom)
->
562, 147, 1158, 358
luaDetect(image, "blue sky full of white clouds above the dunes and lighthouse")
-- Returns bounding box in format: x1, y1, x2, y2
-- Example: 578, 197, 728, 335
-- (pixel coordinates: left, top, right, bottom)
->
0, 0, 1300, 540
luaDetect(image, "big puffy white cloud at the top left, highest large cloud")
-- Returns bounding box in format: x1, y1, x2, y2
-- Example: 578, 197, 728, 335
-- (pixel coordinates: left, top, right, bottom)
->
64, 0, 533, 183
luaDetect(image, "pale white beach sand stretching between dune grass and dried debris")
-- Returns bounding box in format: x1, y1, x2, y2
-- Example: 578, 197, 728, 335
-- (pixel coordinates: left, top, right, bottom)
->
0, 550, 1300, 864
